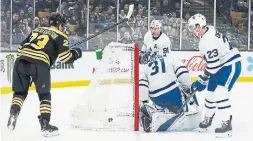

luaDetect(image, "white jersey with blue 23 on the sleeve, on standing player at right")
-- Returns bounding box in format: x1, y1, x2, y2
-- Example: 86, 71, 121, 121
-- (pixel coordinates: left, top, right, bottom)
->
199, 26, 241, 74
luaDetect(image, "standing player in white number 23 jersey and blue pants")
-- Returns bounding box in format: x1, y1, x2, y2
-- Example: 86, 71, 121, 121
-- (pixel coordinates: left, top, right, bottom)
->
188, 14, 241, 137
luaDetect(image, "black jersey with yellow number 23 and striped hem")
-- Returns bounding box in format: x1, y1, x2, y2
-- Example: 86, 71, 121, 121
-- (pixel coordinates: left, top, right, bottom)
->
17, 27, 74, 67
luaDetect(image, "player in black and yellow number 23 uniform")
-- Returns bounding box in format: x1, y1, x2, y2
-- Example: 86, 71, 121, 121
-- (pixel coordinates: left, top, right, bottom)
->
7, 14, 82, 136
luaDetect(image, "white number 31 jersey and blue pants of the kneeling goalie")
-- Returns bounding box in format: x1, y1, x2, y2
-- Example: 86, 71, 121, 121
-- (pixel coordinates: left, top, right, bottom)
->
139, 54, 191, 107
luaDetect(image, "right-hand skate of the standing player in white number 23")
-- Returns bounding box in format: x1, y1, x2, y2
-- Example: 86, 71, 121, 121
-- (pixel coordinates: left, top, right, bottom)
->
215, 115, 232, 138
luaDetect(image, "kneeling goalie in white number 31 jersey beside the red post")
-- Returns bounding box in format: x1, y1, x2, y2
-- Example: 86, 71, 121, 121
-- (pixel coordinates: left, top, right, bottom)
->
139, 48, 201, 132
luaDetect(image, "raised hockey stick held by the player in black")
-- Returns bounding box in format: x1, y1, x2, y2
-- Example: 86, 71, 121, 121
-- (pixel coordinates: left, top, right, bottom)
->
70, 4, 134, 48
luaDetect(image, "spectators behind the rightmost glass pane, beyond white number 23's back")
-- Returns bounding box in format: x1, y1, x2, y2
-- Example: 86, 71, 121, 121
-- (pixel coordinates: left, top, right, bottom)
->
217, 0, 253, 50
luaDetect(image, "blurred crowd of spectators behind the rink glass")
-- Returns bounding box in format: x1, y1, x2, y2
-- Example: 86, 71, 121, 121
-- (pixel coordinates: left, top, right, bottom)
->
1, 0, 253, 50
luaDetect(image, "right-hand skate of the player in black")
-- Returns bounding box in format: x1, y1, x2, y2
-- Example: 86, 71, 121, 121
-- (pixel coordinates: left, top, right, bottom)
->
38, 116, 59, 137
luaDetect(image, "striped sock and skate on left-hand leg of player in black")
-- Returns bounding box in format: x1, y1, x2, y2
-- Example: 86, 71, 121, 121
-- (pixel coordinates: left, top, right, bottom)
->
7, 94, 25, 131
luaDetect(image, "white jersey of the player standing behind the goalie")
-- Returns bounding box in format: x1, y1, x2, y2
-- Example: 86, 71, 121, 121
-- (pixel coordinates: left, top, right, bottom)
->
141, 31, 171, 54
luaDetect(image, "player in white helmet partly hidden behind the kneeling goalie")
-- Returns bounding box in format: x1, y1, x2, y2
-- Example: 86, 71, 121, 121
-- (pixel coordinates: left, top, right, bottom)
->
141, 20, 171, 55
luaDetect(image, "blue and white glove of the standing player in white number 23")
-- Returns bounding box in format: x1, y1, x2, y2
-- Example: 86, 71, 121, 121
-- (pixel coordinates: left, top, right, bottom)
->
191, 75, 209, 92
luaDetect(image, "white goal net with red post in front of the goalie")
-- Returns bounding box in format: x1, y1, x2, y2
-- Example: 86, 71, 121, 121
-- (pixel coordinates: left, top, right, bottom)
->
71, 42, 139, 131
